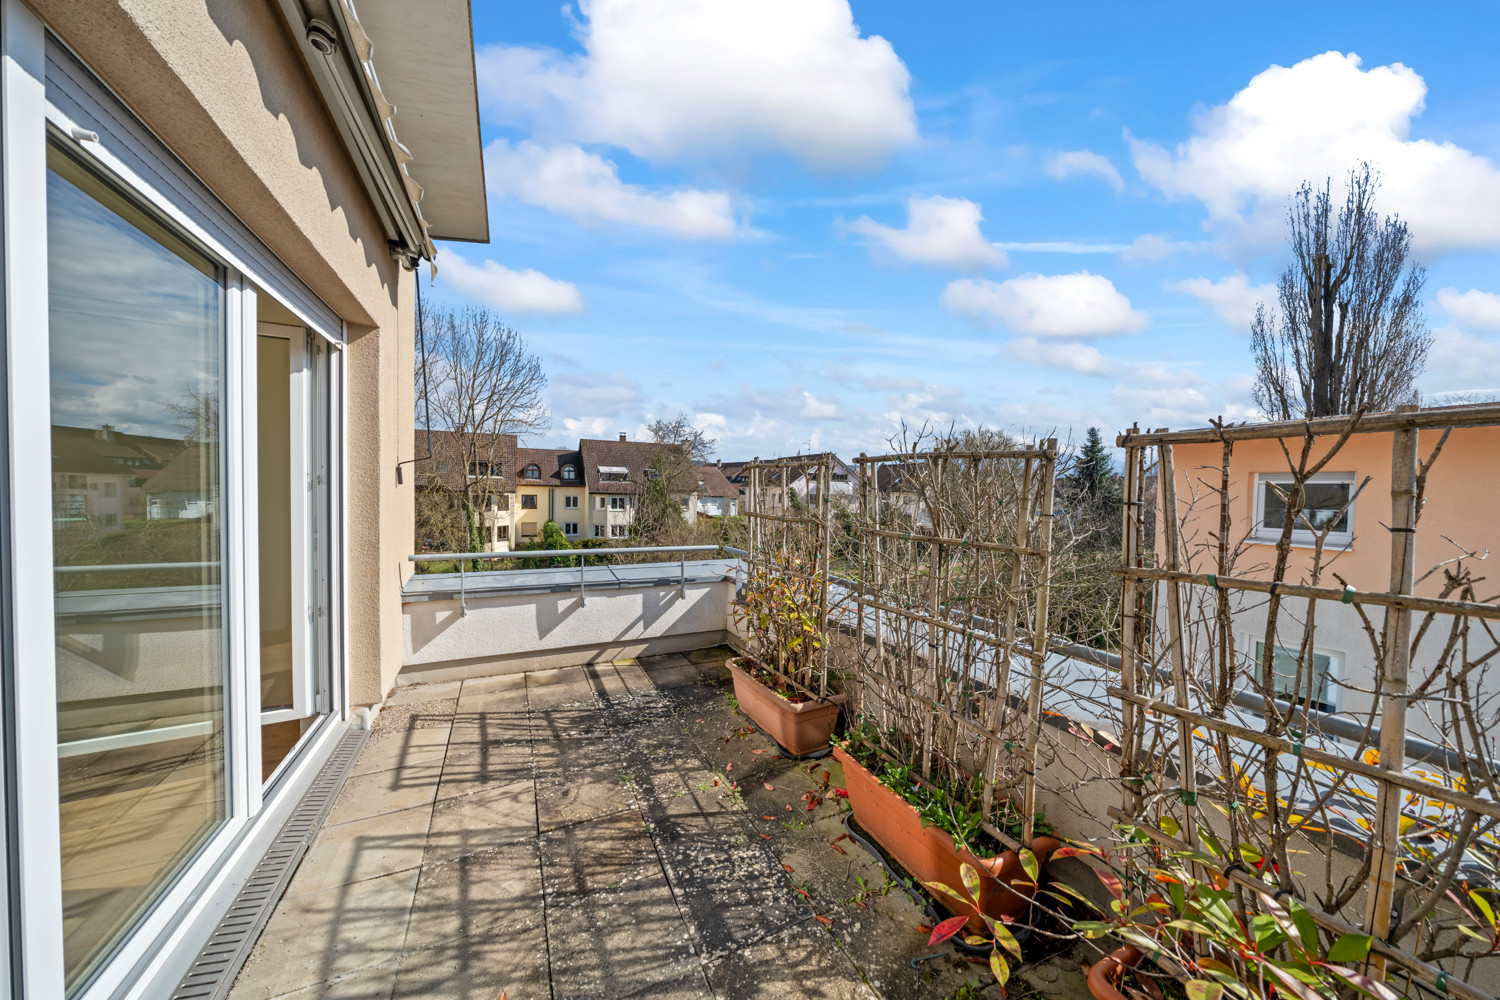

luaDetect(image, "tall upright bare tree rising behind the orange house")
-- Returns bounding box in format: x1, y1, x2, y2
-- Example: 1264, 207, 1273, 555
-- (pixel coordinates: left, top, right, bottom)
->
1250, 163, 1431, 420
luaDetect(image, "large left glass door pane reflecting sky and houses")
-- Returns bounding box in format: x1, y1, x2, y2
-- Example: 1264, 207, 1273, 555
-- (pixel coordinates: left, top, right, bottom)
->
47, 148, 227, 988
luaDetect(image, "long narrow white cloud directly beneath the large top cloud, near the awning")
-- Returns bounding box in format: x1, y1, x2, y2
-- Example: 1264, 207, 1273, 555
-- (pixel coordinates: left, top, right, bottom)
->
485, 139, 737, 240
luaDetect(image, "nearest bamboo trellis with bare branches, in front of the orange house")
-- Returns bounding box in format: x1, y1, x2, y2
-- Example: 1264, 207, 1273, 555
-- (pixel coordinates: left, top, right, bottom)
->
1110, 405, 1500, 1000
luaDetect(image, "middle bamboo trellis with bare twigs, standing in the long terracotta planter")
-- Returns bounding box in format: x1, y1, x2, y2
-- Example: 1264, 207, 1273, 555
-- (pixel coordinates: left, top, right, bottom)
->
849, 439, 1058, 844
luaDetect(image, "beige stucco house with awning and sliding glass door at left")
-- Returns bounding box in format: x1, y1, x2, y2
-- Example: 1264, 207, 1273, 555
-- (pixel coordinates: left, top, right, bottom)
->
0, 0, 488, 1000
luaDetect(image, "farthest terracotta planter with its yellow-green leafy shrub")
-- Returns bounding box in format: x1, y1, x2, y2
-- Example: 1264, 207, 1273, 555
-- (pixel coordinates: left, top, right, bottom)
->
726, 559, 845, 757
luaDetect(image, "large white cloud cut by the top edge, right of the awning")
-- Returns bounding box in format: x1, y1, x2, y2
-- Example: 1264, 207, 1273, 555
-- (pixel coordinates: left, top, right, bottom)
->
476, 0, 918, 169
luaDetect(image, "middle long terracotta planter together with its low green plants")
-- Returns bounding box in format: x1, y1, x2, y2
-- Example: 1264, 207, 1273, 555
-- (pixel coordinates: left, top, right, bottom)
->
834, 728, 1062, 934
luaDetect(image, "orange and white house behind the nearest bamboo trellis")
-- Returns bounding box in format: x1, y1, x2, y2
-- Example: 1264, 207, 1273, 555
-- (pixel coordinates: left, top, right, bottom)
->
1157, 407, 1500, 753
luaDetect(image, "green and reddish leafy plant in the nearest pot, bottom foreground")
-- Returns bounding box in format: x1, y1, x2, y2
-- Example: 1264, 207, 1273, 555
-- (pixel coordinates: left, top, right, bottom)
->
1073, 837, 1397, 1000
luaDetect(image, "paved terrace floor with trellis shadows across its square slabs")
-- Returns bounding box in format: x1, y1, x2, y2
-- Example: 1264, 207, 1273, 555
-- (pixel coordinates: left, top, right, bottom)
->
231, 648, 1088, 1000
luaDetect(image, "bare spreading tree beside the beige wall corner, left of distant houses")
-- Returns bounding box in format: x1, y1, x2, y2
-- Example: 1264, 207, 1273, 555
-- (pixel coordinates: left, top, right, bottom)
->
417, 307, 551, 552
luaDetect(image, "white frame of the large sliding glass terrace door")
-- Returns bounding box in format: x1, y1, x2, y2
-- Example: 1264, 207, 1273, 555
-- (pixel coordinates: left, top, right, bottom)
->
0, 17, 348, 1000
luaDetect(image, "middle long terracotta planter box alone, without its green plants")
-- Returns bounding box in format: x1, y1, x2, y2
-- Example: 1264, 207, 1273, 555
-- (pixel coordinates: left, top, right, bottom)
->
834, 747, 1062, 934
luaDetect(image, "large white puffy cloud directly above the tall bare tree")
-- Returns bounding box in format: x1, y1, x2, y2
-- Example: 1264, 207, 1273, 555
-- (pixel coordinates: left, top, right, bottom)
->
1130, 52, 1500, 252
